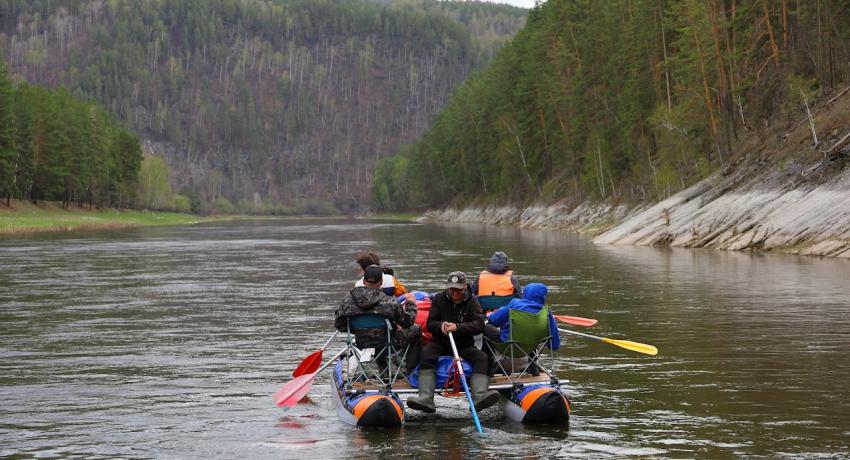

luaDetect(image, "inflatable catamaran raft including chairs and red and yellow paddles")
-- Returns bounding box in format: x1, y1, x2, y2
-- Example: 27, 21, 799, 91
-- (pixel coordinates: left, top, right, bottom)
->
274, 310, 658, 427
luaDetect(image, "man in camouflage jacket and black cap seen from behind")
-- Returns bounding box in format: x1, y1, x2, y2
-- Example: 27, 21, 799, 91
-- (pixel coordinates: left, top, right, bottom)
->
334, 265, 421, 370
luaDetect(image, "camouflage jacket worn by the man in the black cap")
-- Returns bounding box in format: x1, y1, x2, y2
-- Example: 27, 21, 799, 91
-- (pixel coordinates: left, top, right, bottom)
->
334, 286, 416, 347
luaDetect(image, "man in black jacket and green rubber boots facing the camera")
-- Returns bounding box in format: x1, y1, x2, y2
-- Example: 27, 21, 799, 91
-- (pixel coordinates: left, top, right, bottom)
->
407, 272, 499, 413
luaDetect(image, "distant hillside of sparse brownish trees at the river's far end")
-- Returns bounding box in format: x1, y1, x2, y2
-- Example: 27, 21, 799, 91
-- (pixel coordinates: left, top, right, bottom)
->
0, 0, 526, 212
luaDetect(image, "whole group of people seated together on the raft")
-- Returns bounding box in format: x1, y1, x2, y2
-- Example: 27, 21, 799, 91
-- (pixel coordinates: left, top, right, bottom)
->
334, 251, 560, 413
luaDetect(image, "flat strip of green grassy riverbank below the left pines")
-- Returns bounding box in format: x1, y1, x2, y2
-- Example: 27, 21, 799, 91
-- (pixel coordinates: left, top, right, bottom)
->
0, 201, 221, 235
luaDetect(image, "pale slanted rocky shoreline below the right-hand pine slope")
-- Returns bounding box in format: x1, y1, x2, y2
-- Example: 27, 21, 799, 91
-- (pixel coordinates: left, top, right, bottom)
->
423, 155, 850, 259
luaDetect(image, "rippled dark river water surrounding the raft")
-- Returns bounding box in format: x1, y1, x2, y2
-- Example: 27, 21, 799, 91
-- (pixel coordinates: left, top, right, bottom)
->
0, 220, 850, 458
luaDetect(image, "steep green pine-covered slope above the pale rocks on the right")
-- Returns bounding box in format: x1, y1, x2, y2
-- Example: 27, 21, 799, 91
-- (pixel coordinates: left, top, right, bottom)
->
373, 0, 850, 210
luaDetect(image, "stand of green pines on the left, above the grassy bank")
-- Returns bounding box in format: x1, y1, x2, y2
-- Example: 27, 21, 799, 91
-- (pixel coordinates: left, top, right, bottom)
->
0, 61, 142, 207
